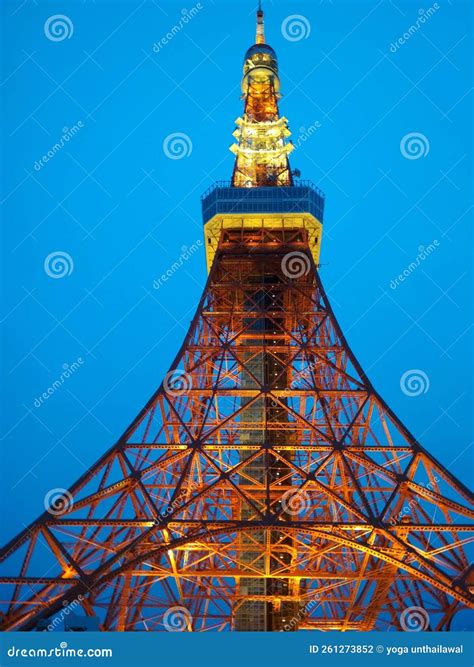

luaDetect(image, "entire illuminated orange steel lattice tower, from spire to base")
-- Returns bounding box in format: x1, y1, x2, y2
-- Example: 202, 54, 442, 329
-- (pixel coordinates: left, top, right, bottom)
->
0, 9, 474, 631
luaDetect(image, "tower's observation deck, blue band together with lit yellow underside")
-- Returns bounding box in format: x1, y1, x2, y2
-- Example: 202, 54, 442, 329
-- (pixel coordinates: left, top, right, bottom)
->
201, 181, 325, 270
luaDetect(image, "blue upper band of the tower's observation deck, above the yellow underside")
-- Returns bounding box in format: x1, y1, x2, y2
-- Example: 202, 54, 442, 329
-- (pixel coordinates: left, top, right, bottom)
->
201, 181, 324, 223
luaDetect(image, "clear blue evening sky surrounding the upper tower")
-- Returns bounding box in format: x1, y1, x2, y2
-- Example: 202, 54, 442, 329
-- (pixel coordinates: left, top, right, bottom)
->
1, 0, 473, 538
